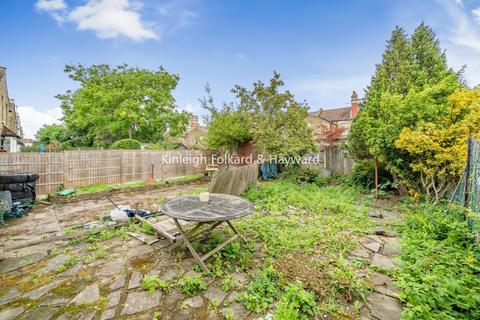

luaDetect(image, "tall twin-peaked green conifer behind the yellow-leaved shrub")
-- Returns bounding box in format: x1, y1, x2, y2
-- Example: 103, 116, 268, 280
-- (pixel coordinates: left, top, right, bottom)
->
348, 23, 461, 192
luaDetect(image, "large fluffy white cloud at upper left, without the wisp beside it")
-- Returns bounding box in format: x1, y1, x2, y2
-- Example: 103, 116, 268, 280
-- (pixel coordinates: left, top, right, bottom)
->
68, 0, 158, 41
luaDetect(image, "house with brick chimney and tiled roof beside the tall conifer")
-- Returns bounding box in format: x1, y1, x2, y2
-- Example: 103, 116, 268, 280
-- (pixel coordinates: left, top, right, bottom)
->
307, 91, 362, 145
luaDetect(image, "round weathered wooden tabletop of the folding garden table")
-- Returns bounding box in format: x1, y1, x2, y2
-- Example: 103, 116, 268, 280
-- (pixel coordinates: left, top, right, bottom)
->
160, 193, 254, 222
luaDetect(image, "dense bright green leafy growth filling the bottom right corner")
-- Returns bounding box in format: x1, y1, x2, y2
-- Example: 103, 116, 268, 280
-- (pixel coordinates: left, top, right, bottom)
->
397, 205, 480, 319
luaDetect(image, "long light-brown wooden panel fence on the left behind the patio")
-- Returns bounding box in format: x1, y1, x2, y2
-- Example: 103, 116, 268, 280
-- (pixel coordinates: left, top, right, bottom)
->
0, 150, 212, 194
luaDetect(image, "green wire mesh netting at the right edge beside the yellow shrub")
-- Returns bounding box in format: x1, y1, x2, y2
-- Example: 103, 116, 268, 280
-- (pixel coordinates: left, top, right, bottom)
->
452, 138, 480, 232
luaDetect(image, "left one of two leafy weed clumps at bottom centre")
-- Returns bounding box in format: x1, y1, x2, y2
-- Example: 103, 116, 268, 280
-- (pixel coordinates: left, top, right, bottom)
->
240, 266, 280, 312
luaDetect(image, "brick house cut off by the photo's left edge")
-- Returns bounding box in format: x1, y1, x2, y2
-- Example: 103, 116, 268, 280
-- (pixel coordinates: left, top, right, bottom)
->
0, 66, 23, 152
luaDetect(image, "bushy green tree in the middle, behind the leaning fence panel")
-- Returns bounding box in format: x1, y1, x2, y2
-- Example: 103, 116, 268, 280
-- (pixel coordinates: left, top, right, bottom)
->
202, 72, 315, 157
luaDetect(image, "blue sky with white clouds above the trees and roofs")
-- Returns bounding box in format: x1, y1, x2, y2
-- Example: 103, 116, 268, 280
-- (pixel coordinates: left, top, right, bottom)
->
0, 0, 480, 138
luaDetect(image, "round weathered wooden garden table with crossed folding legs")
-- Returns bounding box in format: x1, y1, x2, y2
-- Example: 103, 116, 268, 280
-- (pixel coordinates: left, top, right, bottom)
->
160, 193, 254, 272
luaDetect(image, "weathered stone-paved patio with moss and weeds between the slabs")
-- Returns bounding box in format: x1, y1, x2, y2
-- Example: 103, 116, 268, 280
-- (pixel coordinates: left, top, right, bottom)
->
0, 179, 401, 319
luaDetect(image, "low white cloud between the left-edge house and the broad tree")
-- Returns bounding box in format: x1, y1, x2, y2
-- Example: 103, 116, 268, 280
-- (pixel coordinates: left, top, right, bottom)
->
17, 106, 62, 139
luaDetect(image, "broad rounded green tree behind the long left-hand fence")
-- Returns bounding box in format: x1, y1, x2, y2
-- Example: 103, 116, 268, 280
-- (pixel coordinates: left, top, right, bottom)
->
57, 64, 189, 146
